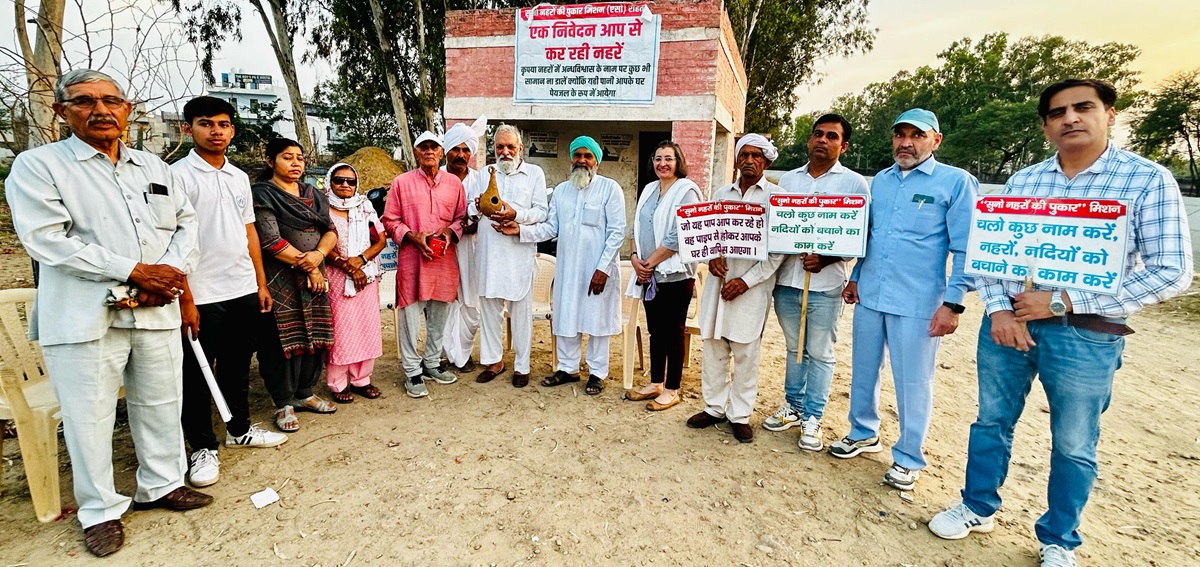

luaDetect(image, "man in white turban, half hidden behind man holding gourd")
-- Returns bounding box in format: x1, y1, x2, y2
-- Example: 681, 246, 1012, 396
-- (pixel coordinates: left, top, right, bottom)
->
442, 117, 487, 372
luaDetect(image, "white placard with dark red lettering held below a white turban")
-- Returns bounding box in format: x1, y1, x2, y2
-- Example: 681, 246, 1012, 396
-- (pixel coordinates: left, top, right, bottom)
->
676, 201, 767, 263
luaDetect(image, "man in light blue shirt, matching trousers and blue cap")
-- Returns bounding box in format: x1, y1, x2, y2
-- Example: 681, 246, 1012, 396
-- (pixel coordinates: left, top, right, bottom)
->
829, 108, 979, 490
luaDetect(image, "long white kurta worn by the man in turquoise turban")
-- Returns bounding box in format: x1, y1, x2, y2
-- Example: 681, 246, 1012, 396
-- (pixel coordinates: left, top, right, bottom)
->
521, 175, 625, 336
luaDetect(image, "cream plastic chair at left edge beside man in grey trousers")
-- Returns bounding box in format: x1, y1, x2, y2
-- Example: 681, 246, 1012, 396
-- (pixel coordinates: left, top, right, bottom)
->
0, 288, 62, 521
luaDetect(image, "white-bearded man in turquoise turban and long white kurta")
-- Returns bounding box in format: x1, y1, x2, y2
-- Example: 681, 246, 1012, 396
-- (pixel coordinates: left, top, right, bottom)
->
496, 136, 625, 395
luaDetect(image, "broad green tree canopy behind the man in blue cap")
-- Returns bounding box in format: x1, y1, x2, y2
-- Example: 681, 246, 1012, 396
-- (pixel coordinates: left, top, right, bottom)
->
832, 32, 1140, 181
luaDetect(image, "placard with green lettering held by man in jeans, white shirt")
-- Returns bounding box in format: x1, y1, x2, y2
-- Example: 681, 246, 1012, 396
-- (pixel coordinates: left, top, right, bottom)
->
767, 193, 871, 258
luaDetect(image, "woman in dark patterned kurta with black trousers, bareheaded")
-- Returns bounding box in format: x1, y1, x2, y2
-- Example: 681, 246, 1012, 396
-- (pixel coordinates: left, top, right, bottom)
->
251, 138, 337, 432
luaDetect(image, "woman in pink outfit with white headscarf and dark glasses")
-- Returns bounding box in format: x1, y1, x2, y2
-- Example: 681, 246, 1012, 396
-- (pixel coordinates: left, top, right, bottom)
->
325, 163, 388, 404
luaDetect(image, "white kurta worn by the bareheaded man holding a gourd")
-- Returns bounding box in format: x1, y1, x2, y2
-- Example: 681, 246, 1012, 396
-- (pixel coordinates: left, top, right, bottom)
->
470, 162, 548, 302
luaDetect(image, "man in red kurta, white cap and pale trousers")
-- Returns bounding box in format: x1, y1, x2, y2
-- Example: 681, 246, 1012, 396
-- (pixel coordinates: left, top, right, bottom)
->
383, 132, 467, 398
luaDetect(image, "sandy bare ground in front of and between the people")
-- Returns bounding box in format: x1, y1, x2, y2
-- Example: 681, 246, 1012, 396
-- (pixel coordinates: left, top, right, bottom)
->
0, 252, 1200, 567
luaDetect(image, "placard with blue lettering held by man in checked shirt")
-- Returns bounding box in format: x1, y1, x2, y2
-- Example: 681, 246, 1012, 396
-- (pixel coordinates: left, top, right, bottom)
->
966, 196, 1129, 296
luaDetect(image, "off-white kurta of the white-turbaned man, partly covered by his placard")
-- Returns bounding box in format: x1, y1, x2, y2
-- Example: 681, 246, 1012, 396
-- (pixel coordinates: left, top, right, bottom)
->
698, 178, 785, 342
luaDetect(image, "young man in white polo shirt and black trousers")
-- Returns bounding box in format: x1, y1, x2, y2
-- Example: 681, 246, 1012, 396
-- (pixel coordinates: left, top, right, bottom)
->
170, 96, 288, 487
